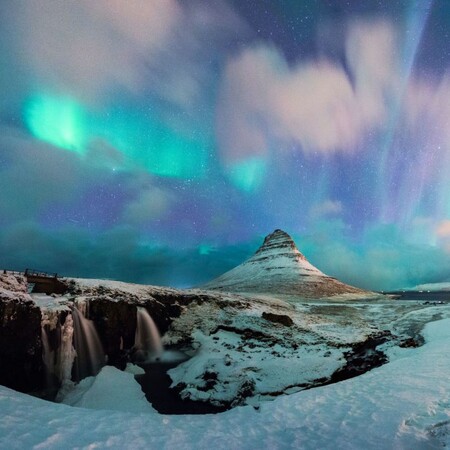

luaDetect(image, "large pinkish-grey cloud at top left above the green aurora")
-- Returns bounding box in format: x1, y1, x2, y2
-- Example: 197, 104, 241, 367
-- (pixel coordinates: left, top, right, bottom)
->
16, 0, 180, 99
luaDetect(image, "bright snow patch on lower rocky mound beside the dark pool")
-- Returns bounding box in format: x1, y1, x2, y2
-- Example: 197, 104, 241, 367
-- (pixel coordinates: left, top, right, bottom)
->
168, 331, 348, 405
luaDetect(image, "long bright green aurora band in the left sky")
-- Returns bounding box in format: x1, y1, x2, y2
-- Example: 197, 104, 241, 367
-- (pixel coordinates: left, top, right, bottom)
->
23, 94, 209, 179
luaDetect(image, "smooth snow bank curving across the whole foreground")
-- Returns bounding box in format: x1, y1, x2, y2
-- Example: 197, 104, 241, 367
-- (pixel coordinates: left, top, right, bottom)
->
0, 319, 450, 450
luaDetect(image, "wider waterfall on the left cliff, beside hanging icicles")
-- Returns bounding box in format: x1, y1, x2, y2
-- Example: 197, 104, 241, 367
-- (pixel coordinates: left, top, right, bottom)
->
72, 308, 105, 381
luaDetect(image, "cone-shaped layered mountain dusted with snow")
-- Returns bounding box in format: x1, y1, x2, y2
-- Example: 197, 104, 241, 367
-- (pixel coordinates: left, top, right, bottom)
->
201, 230, 368, 298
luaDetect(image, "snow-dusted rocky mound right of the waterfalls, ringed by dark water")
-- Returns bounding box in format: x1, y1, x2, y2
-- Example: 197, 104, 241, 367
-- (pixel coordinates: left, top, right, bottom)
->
163, 294, 384, 406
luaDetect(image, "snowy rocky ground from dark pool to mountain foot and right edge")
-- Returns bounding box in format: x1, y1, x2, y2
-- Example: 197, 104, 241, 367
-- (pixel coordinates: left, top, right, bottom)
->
163, 295, 450, 405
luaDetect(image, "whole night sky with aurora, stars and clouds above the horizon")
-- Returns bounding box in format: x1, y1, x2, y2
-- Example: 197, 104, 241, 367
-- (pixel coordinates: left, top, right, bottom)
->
0, 0, 450, 289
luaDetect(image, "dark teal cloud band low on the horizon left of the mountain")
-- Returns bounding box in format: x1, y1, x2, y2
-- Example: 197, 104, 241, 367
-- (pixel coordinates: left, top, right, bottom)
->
0, 221, 251, 287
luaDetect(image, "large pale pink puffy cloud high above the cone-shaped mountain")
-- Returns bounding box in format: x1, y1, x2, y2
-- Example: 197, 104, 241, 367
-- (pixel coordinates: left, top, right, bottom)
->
216, 21, 398, 167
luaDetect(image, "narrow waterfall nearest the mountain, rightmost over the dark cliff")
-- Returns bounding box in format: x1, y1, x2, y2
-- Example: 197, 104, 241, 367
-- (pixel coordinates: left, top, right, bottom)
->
134, 306, 163, 361
